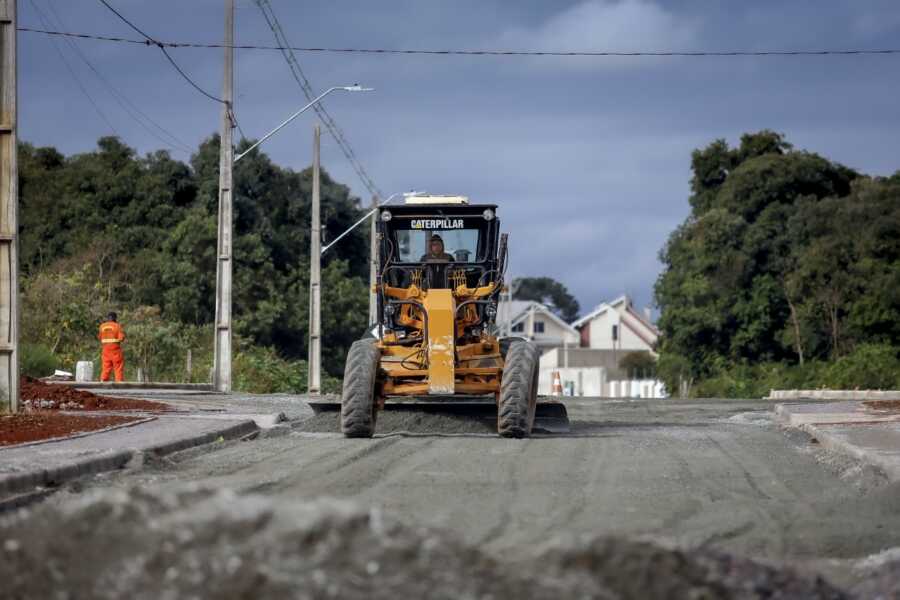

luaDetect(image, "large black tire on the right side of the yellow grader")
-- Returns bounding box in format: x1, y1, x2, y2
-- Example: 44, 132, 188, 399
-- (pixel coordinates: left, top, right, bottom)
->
497, 341, 539, 438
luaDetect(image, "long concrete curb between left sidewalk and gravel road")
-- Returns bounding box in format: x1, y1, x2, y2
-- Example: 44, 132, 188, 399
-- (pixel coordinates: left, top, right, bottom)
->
0, 421, 258, 511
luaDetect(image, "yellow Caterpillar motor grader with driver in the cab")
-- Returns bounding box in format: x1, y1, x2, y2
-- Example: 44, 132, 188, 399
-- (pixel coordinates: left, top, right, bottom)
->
318, 195, 568, 438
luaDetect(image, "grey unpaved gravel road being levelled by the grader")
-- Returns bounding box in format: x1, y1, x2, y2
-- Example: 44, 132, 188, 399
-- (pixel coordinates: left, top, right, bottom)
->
7, 400, 900, 587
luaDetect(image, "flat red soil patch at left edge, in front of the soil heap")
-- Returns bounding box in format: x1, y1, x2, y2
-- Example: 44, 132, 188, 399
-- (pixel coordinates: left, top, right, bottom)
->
0, 412, 138, 446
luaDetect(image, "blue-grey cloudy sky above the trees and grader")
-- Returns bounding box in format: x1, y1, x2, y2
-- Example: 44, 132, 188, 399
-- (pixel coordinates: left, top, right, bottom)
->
19, 0, 900, 318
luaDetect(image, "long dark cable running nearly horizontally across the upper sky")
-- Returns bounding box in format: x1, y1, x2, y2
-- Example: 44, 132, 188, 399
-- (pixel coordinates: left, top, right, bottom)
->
18, 27, 900, 58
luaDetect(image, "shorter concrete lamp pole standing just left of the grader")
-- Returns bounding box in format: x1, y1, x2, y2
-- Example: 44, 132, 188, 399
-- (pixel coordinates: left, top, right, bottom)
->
307, 124, 322, 396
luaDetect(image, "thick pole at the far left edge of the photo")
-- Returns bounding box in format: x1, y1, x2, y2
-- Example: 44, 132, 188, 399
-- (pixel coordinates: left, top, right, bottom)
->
0, 0, 19, 412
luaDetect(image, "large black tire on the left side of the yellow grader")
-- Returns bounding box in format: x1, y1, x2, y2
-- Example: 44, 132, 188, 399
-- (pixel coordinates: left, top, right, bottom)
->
341, 340, 381, 437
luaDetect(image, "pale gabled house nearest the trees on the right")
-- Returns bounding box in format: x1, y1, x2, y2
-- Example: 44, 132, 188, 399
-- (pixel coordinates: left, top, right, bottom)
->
572, 296, 659, 356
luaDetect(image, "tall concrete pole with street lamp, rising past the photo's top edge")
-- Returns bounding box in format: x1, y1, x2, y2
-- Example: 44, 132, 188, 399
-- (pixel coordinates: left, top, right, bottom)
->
213, 0, 234, 393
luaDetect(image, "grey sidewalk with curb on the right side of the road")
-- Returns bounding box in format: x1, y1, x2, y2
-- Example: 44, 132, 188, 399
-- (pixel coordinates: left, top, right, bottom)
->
775, 402, 900, 482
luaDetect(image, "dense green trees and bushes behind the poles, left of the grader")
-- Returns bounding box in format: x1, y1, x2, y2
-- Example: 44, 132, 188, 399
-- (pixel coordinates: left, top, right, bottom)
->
19, 136, 368, 381
